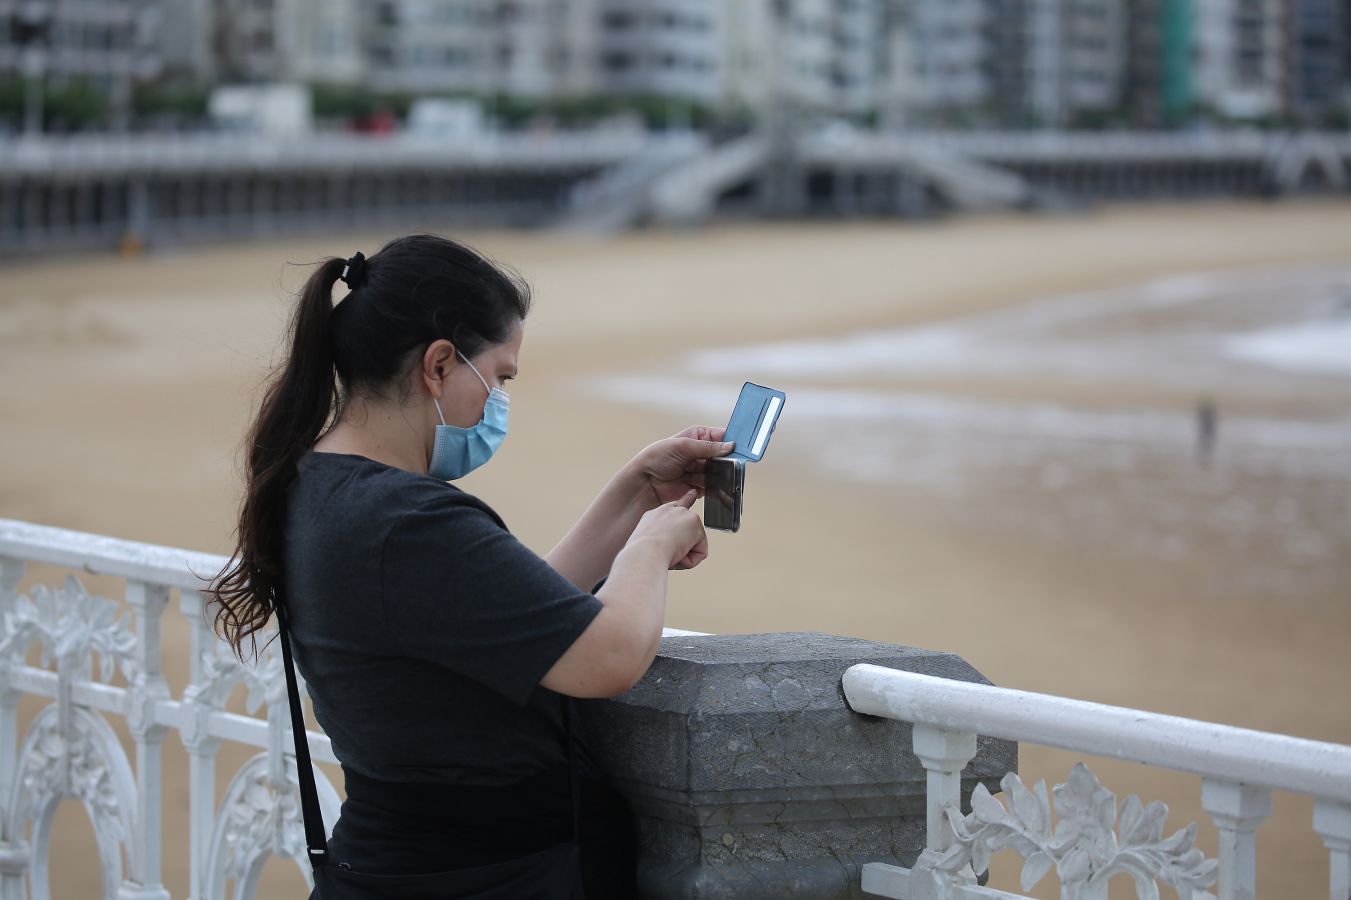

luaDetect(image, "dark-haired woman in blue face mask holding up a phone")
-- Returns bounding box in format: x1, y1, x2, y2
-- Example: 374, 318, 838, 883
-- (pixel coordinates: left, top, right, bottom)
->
213, 235, 732, 900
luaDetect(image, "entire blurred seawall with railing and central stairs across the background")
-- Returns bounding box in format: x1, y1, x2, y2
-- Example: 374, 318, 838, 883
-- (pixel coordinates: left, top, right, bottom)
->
0, 128, 1351, 254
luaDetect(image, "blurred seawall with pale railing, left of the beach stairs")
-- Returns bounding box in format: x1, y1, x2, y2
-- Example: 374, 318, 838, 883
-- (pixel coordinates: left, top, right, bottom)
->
0, 132, 692, 253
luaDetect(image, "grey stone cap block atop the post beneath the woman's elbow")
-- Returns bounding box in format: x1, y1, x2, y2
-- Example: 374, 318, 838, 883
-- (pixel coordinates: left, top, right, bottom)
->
586, 632, 1016, 792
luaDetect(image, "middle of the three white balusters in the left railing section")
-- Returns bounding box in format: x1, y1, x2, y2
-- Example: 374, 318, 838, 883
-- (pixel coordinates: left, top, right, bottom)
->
127, 581, 169, 900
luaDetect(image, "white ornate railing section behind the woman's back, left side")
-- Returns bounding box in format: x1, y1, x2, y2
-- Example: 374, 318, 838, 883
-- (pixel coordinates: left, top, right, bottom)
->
0, 519, 339, 900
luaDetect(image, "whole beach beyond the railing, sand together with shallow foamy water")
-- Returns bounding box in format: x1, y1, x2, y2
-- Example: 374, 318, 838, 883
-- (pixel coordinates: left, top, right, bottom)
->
0, 203, 1351, 899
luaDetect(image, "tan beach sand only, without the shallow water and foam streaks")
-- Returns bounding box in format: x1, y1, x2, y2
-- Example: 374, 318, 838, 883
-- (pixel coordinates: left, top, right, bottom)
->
0, 204, 1351, 897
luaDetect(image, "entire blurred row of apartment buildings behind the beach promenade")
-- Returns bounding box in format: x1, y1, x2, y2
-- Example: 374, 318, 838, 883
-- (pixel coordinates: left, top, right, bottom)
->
0, 0, 1351, 127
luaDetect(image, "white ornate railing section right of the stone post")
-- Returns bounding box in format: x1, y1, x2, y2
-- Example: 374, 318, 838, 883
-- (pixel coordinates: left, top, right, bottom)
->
844, 665, 1351, 900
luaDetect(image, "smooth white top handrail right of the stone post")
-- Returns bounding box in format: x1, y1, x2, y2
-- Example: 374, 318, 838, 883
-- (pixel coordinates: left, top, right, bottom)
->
844, 665, 1351, 803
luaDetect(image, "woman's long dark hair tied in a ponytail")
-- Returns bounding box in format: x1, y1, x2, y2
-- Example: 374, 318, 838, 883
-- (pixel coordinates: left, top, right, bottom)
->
208, 235, 530, 658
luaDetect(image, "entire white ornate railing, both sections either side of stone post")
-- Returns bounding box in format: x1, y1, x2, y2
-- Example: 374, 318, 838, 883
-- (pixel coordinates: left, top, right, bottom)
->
10, 510, 1351, 900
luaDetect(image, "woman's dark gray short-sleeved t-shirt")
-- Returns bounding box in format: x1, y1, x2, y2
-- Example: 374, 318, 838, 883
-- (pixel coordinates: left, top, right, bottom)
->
285, 453, 601, 785
